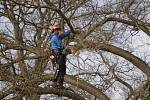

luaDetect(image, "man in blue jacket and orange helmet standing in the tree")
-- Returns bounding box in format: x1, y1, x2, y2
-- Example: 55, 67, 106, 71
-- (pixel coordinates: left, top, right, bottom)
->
49, 23, 70, 88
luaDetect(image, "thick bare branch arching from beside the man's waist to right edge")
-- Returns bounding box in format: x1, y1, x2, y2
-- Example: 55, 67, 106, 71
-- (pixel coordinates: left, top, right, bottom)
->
79, 40, 150, 78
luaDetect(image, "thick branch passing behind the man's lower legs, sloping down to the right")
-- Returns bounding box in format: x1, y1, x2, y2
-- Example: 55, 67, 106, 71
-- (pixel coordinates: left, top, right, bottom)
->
28, 74, 109, 100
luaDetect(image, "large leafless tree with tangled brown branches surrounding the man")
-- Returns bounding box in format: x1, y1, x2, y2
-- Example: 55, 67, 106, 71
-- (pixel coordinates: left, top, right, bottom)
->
0, 0, 150, 100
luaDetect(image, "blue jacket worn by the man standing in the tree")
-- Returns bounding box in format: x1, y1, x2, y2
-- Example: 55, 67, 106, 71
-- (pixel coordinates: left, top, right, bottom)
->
49, 30, 70, 49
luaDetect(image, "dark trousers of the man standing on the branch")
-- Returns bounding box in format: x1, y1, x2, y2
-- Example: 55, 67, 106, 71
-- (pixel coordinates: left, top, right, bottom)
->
52, 49, 66, 85
